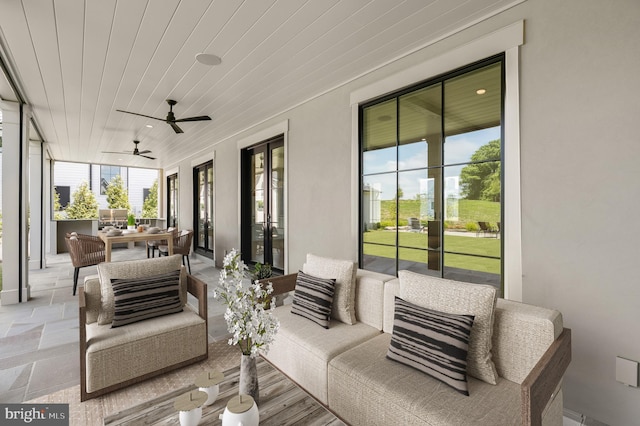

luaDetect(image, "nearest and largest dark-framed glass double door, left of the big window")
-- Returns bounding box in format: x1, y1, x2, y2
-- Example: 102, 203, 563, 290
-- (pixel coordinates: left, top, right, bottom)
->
241, 135, 285, 273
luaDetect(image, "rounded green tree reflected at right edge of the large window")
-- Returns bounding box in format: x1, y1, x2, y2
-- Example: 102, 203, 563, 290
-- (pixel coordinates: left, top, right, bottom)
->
460, 139, 500, 201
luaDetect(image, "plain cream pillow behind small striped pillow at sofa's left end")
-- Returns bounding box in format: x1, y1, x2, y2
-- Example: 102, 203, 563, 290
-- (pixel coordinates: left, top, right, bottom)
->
302, 254, 357, 325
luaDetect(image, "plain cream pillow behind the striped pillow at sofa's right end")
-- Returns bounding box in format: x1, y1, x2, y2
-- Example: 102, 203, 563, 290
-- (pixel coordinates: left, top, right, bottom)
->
398, 271, 498, 385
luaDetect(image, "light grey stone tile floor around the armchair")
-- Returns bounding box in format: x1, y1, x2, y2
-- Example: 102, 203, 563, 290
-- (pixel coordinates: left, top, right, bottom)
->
0, 246, 228, 403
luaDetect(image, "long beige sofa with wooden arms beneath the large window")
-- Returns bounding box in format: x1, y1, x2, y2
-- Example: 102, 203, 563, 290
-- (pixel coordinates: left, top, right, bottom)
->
264, 258, 571, 426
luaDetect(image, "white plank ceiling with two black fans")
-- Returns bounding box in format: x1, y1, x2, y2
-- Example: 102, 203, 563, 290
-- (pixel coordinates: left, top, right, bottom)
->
0, 0, 519, 167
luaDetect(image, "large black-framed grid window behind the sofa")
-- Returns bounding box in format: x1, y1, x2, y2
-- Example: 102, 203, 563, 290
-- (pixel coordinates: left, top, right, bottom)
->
360, 55, 504, 288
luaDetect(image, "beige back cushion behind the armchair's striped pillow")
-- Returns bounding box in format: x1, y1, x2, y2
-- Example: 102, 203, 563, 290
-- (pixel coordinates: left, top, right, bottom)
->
98, 254, 187, 325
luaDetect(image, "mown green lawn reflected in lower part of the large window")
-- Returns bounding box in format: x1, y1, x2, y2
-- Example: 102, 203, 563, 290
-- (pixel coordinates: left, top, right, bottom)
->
363, 230, 500, 274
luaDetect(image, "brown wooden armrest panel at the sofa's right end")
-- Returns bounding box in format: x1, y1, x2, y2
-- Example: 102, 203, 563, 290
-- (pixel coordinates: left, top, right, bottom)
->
520, 328, 571, 425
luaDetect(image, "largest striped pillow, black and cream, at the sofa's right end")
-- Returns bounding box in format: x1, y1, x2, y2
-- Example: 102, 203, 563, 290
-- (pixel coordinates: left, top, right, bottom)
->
387, 297, 474, 396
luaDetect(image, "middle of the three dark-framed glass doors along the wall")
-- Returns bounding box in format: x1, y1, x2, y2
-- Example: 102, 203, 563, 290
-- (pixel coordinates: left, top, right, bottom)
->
193, 161, 213, 259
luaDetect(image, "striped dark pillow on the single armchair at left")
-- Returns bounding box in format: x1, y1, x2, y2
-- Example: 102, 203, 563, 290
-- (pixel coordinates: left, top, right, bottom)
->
111, 270, 182, 328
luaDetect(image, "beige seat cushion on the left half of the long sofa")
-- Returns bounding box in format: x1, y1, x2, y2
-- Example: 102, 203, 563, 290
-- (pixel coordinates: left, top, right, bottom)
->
263, 305, 380, 404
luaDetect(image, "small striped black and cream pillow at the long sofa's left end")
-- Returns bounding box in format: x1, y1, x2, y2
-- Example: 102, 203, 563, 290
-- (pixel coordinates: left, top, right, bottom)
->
291, 271, 336, 328
